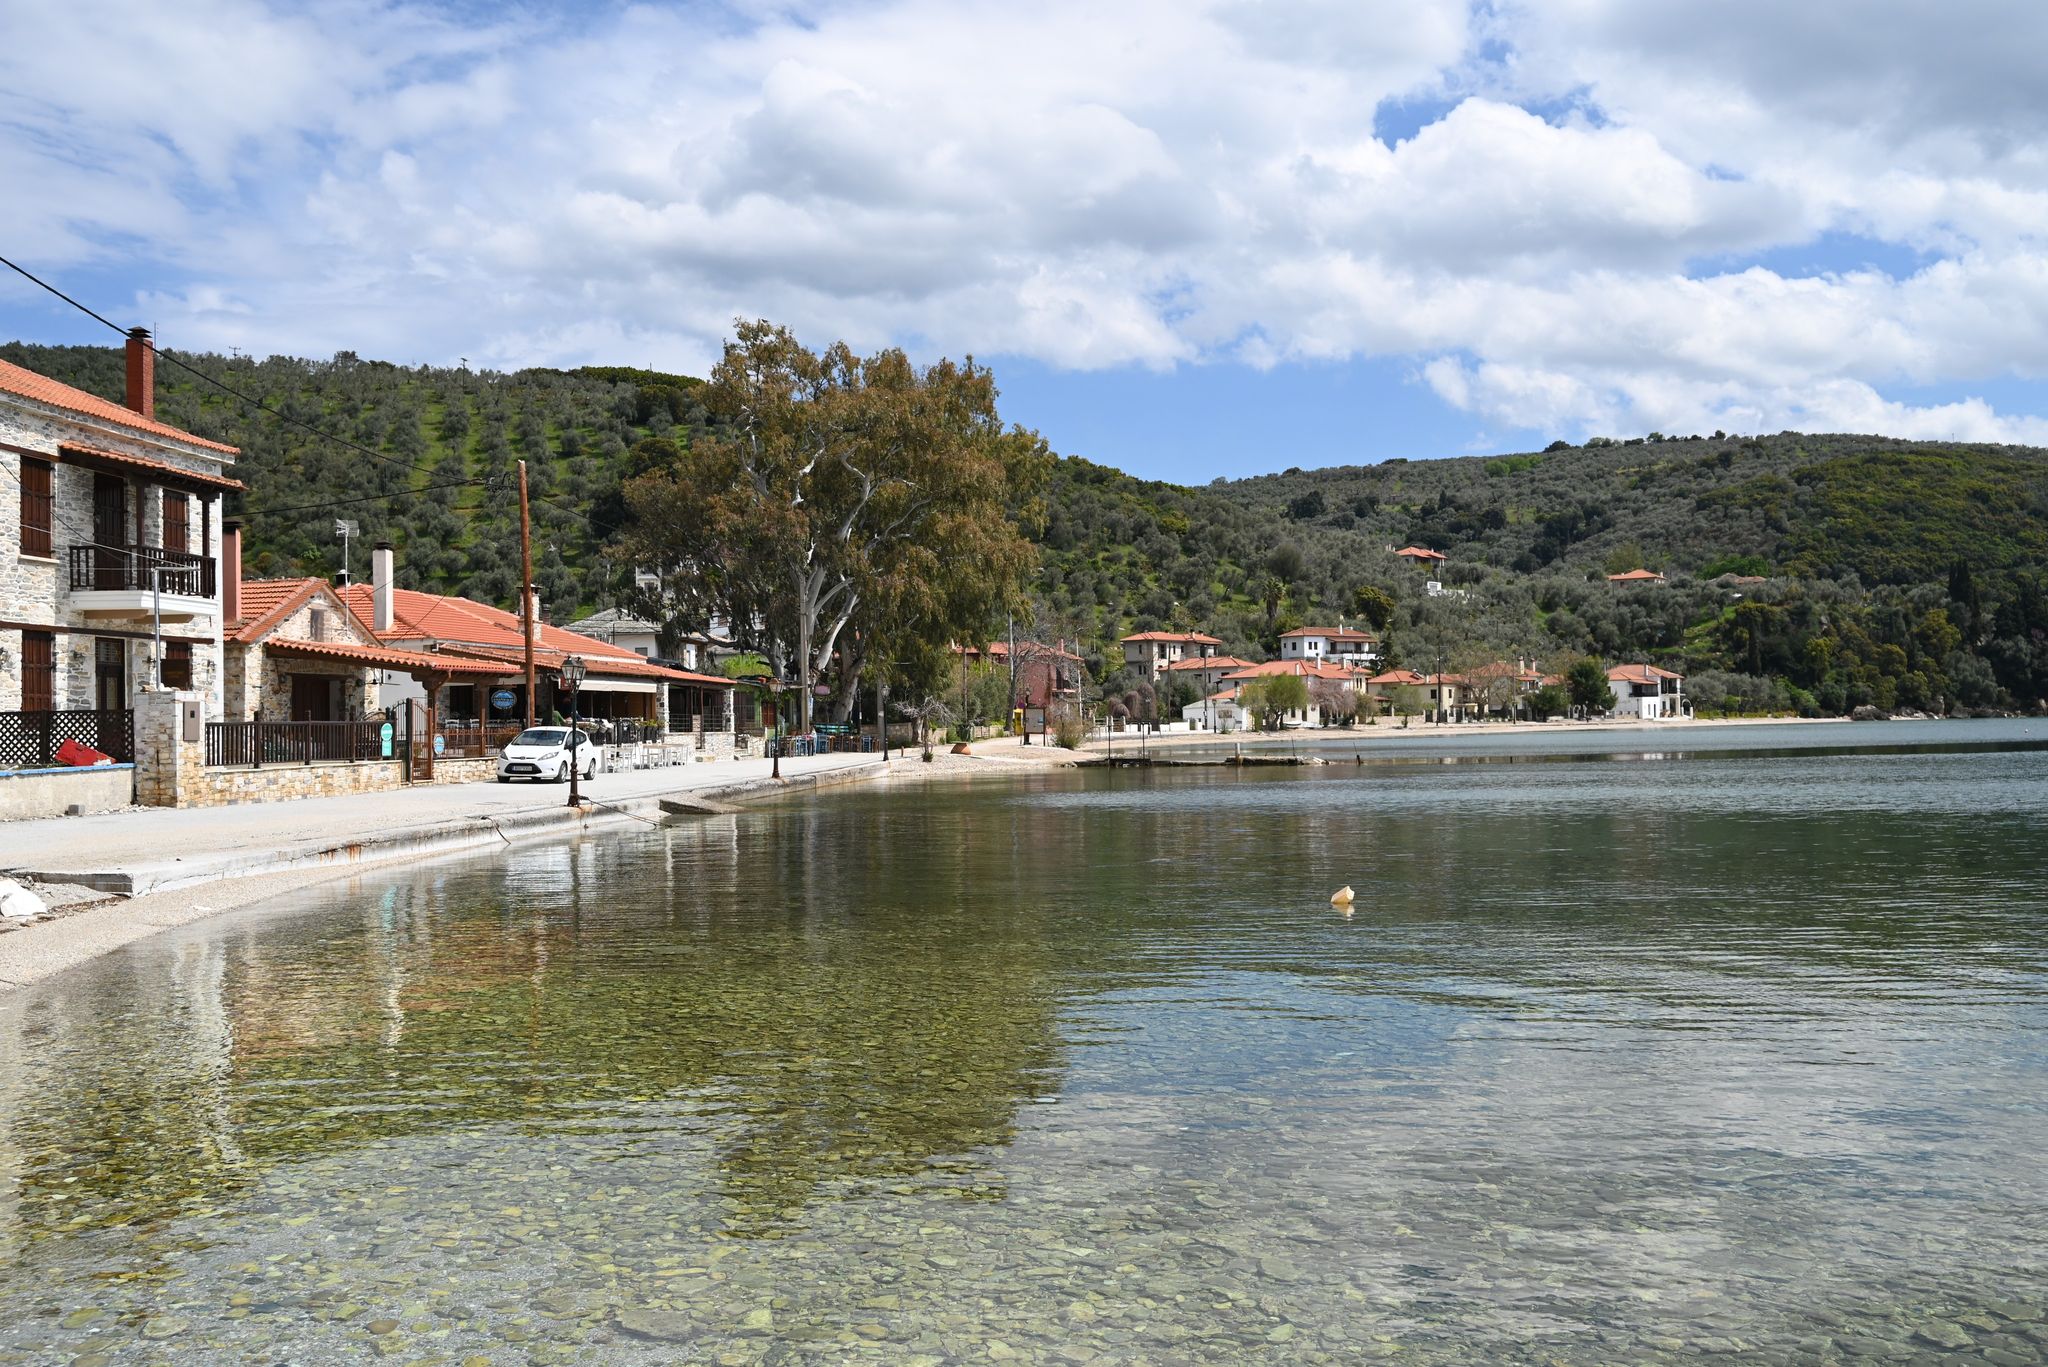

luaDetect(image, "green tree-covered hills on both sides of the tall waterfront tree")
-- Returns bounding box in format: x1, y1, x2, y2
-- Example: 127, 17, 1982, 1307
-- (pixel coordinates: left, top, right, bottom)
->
12, 344, 2048, 713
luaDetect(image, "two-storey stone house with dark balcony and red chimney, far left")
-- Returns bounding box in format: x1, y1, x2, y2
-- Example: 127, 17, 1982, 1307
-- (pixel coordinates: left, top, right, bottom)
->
0, 328, 242, 769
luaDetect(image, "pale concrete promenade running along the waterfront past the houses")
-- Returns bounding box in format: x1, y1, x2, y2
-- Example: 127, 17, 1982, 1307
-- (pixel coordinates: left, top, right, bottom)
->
0, 752, 888, 896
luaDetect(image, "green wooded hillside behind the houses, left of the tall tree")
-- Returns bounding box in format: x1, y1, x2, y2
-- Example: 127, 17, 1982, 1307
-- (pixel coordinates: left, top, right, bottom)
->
0, 342, 702, 621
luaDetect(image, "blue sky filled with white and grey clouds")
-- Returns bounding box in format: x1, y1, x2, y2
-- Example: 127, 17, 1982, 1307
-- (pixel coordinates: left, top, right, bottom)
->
0, 0, 2048, 484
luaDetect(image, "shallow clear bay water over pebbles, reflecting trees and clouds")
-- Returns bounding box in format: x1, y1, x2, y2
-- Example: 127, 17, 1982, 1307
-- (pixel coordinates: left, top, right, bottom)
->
0, 723, 2048, 1365
